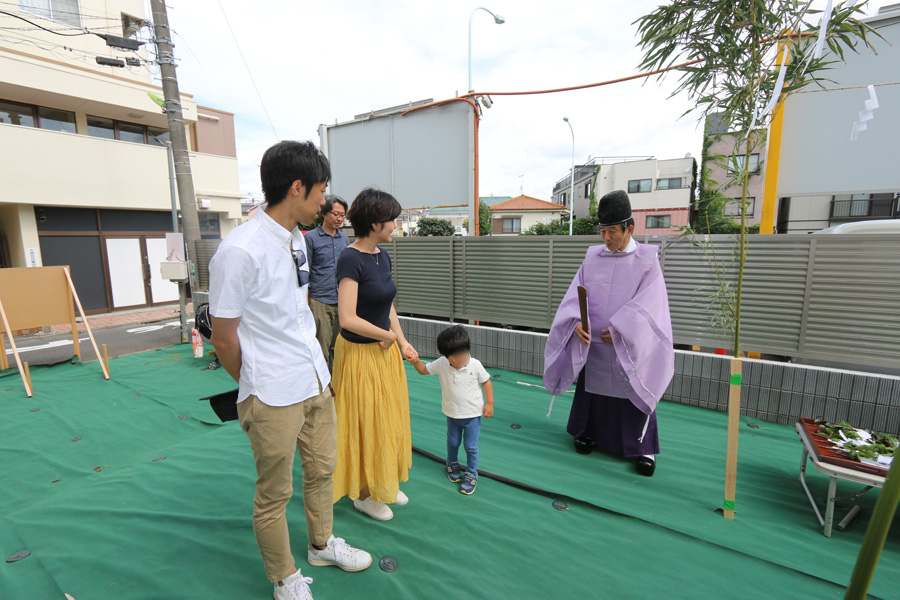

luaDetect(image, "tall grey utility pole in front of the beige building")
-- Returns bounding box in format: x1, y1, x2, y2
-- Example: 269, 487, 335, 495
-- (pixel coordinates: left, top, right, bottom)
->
150, 0, 200, 318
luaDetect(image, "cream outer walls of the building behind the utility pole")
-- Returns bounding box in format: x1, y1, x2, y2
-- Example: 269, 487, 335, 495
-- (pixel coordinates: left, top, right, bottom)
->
0, 0, 241, 266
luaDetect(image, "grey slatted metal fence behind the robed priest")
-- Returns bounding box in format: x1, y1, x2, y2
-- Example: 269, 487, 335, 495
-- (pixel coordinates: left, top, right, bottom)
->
383, 235, 900, 367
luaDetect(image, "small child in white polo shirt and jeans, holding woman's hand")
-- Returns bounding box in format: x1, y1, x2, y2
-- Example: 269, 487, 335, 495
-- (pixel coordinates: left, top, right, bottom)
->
412, 325, 494, 495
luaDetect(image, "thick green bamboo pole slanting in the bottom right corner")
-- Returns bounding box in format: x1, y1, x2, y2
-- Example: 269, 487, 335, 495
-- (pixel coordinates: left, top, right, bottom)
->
844, 459, 900, 600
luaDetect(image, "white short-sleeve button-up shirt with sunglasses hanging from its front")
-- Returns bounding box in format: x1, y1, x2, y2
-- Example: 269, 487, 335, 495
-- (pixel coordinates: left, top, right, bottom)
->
209, 210, 331, 406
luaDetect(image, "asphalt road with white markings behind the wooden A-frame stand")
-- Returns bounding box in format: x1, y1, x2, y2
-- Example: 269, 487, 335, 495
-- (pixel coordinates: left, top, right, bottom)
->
6, 318, 195, 367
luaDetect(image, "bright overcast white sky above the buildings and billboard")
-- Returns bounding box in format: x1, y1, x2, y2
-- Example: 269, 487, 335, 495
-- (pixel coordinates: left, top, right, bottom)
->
158, 0, 889, 200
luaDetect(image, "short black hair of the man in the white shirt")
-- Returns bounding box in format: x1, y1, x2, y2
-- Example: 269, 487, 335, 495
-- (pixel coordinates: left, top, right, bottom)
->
259, 141, 331, 206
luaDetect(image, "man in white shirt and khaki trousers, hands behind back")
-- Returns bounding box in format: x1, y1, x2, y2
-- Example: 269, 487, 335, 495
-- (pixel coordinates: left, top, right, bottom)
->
209, 141, 372, 600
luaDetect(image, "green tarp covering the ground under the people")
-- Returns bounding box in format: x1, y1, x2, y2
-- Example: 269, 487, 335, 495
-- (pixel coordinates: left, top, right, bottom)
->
0, 346, 900, 600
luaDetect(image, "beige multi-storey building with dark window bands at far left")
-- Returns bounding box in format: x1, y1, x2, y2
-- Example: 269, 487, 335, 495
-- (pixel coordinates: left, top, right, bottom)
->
0, 0, 241, 312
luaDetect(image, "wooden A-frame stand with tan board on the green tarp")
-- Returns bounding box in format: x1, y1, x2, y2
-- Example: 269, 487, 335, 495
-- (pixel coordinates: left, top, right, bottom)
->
0, 267, 109, 398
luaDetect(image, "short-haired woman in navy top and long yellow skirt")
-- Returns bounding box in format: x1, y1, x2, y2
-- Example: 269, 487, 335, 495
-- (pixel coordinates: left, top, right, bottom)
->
333, 188, 418, 521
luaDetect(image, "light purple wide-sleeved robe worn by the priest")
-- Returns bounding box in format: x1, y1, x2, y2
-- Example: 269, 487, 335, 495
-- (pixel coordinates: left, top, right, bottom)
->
544, 243, 675, 428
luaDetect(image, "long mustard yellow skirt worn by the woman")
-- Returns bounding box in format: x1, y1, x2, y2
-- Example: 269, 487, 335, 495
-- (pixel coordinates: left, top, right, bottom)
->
332, 336, 412, 503
